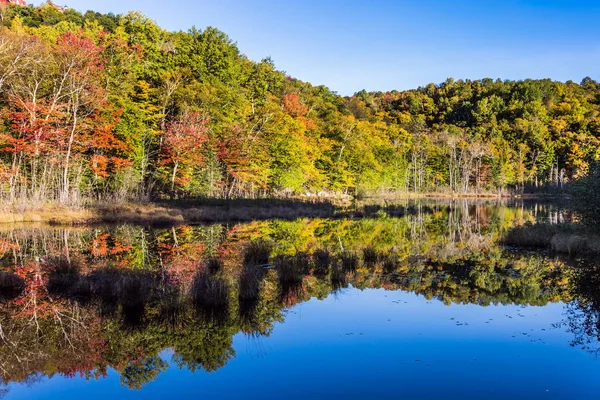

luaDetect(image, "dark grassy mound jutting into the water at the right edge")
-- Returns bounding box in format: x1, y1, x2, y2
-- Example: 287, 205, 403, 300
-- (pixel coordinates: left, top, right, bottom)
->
502, 224, 600, 256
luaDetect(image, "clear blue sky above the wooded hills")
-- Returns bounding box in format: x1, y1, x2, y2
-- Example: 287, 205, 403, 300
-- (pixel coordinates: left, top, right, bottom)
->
34, 0, 600, 95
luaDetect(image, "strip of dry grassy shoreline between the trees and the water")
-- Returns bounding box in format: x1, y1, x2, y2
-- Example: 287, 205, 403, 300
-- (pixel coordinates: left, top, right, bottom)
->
0, 193, 565, 226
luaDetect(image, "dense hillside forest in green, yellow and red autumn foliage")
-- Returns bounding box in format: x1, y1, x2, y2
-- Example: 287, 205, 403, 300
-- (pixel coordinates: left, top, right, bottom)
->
0, 1, 600, 204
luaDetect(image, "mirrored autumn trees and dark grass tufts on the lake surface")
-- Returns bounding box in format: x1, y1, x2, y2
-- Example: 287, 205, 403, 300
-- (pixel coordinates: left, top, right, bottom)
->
0, 203, 600, 396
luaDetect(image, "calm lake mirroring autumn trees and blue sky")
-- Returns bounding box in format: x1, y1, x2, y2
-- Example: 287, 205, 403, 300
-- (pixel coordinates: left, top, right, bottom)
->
0, 201, 600, 400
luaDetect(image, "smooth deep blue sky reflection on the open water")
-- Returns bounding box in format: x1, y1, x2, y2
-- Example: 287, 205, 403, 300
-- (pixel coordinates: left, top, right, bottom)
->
6, 289, 600, 400
